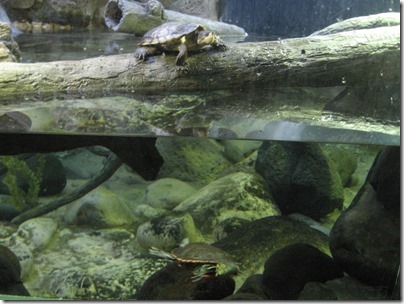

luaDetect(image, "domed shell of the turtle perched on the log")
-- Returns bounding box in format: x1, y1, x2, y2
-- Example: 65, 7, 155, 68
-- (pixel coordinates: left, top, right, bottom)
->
139, 22, 205, 46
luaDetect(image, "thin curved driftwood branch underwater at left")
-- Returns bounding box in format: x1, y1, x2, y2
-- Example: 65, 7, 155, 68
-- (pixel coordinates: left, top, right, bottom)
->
11, 153, 122, 225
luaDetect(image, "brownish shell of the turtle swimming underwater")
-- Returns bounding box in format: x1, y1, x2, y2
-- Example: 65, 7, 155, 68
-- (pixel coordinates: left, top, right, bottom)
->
171, 242, 233, 264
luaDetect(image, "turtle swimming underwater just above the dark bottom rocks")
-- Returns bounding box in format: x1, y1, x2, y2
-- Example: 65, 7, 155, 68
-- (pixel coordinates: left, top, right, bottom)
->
149, 242, 240, 282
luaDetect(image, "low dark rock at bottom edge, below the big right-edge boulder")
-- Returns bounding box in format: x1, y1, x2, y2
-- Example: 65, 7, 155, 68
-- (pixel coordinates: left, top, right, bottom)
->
298, 276, 389, 301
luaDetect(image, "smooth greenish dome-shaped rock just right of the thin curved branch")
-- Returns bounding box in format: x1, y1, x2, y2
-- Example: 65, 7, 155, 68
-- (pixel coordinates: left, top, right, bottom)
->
63, 187, 138, 228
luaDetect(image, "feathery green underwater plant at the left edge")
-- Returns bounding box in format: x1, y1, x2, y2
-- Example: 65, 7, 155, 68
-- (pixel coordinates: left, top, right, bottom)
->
1, 154, 46, 210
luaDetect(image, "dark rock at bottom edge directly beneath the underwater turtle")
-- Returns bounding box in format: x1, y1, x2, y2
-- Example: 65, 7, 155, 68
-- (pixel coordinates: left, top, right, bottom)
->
137, 263, 235, 301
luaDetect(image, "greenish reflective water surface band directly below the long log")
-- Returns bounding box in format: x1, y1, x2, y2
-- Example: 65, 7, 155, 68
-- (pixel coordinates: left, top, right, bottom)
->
0, 87, 400, 145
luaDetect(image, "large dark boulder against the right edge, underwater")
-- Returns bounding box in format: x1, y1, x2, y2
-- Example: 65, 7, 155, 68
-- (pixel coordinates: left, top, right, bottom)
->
330, 147, 401, 292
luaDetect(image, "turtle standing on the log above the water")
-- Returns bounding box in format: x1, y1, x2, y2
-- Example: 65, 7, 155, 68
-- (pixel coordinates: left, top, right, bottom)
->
135, 22, 227, 66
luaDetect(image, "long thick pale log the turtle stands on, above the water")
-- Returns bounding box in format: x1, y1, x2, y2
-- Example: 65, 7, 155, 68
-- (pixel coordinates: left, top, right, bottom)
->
0, 16, 400, 101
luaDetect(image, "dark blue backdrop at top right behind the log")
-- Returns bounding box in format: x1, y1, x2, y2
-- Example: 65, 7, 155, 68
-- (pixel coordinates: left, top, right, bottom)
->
219, 0, 400, 38
